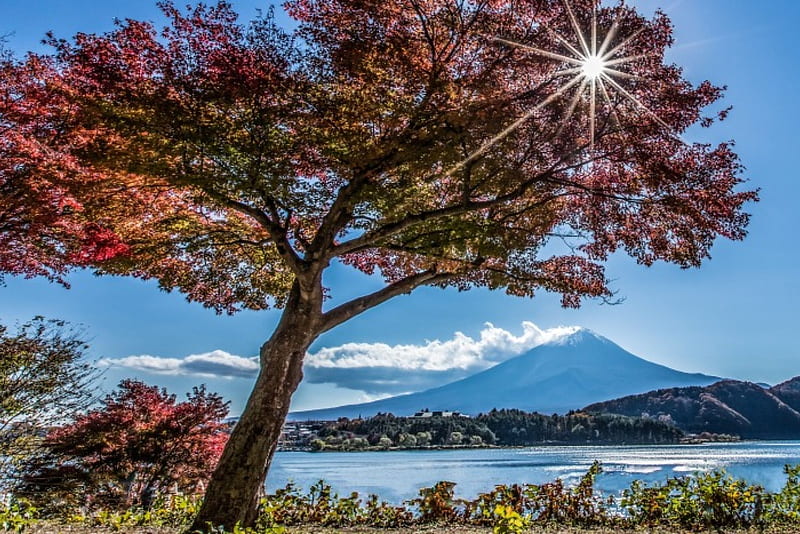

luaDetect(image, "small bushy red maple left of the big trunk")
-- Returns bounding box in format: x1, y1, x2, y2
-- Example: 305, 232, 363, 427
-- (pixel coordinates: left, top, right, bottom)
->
15, 380, 228, 508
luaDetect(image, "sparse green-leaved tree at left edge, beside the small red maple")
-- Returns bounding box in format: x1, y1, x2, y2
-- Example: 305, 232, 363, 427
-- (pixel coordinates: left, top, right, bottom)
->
0, 317, 96, 490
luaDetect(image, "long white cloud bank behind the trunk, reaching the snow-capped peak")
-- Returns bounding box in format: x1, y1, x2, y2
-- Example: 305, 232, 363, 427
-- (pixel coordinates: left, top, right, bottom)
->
102, 321, 578, 395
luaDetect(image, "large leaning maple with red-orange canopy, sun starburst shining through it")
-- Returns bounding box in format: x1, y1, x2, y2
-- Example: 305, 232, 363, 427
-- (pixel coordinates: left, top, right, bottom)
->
3, 0, 756, 528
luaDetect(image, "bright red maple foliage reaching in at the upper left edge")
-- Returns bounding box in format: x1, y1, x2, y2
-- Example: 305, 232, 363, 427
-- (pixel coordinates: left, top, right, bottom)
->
0, 41, 133, 283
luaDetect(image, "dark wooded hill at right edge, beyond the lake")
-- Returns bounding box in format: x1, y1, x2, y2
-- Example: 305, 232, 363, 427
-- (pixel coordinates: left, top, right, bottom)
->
585, 377, 800, 439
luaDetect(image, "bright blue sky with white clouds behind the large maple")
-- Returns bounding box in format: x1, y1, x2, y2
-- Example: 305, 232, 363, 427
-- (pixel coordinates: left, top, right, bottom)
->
0, 0, 800, 412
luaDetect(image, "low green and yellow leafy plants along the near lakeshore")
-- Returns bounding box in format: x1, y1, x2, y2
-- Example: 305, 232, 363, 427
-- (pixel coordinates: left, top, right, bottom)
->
10, 462, 800, 534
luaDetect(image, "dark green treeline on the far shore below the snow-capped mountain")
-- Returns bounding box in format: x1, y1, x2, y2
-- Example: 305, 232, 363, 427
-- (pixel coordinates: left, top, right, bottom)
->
306, 410, 683, 450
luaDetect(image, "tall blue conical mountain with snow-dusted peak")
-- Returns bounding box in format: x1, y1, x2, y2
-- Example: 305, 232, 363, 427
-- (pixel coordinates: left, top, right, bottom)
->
289, 329, 719, 420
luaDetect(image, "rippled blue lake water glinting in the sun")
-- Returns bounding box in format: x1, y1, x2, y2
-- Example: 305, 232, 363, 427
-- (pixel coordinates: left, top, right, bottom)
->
267, 441, 800, 504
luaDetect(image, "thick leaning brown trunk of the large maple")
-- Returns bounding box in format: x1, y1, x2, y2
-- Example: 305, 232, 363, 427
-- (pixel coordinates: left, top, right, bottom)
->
189, 282, 321, 532
